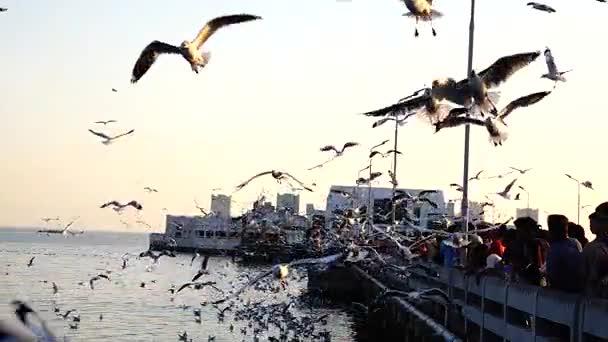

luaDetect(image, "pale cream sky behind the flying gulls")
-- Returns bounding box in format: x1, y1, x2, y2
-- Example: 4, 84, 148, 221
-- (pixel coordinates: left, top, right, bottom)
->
0, 0, 608, 231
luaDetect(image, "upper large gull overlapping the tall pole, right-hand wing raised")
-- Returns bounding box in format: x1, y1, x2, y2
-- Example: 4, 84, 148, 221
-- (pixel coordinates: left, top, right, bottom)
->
432, 51, 540, 115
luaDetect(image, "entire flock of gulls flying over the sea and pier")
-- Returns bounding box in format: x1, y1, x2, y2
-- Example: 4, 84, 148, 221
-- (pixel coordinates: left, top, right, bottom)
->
0, 0, 606, 341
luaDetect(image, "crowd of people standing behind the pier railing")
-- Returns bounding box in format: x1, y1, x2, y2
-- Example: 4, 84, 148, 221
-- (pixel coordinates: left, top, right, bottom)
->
423, 202, 608, 298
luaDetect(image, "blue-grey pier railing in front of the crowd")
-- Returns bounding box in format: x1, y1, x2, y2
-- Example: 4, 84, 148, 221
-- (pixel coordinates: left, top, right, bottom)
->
399, 267, 608, 342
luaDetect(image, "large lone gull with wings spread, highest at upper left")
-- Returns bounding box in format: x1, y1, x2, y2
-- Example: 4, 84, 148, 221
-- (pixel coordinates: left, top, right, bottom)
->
131, 14, 262, 83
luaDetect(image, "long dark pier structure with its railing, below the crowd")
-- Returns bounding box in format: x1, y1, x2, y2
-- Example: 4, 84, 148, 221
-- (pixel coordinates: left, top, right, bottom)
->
309, 265, 608, 342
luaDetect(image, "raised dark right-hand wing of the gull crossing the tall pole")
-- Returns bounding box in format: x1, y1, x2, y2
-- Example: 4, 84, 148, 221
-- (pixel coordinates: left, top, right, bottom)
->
479, 51, 540, 88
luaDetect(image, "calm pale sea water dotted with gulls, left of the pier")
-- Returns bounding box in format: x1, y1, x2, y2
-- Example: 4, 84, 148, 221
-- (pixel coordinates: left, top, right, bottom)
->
0, 230, 355, 342
